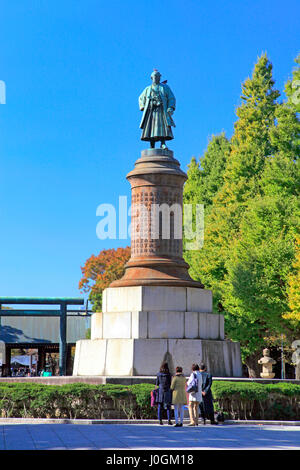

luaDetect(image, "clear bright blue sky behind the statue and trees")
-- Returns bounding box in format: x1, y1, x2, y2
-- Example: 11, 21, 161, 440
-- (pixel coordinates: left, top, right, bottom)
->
0, 0, 300, 297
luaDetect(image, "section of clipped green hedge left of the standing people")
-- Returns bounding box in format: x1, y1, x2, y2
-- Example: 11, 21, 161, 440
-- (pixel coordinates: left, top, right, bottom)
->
0, 382, 155, 419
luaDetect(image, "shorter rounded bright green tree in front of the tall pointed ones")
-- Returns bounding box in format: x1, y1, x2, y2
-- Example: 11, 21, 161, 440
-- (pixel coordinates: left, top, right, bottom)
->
222, 196, 296, 376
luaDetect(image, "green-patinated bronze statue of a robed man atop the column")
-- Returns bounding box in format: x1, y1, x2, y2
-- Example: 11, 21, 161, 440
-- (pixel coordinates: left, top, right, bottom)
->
139, 69, 176, 148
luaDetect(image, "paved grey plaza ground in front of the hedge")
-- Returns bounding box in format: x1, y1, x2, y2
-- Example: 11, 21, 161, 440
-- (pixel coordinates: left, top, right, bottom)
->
0, 424, 300, 450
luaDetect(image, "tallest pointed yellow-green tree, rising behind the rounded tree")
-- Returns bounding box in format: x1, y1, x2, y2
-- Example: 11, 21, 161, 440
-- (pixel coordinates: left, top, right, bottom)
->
195, 54, 279, 302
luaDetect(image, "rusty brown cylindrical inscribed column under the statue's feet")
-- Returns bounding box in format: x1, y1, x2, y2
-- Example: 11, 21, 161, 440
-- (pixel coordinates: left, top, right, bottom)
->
110, 149, 203, 288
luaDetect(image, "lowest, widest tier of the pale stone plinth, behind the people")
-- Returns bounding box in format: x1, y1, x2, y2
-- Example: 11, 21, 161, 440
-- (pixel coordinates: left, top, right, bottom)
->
73, 339, 242, 377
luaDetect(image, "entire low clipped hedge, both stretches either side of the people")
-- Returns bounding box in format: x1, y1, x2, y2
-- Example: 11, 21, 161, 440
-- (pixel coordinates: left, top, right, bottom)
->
0, 381, 300, 420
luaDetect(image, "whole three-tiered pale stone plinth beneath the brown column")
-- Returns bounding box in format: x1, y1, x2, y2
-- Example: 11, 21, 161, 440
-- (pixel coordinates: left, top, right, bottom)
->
73, 286, 242, 377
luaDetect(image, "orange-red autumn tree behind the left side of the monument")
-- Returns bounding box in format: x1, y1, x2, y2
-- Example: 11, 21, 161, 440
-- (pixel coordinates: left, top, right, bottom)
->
79, 246, 130, 311
